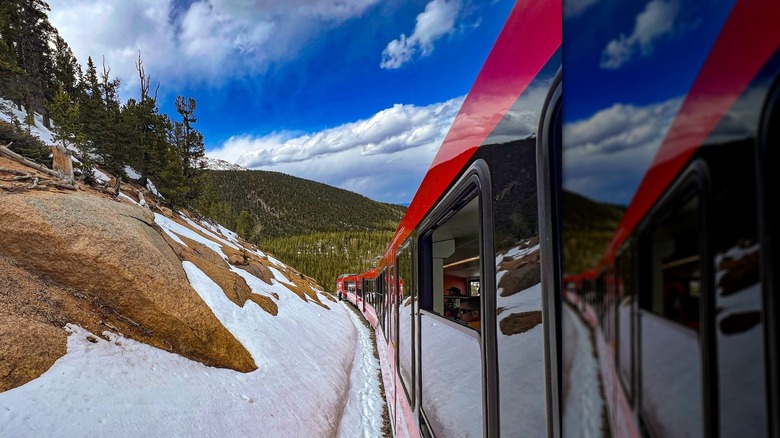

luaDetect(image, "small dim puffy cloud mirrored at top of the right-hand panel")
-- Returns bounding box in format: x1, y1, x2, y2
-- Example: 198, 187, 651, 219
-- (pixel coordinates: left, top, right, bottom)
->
600, 0, 680, 70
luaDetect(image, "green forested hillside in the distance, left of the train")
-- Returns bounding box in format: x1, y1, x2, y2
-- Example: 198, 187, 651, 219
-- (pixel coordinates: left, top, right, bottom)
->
197, 170, 406, 289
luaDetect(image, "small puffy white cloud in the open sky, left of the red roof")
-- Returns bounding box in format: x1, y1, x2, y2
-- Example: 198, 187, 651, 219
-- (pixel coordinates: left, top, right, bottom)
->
380, 0, 460, 69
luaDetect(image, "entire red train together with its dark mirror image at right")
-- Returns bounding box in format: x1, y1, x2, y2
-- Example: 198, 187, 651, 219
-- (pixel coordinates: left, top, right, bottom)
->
337, 0, 780, 437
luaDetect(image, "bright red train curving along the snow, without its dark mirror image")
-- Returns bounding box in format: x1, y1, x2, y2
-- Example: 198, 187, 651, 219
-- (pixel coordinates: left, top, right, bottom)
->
340, 0, 562, 437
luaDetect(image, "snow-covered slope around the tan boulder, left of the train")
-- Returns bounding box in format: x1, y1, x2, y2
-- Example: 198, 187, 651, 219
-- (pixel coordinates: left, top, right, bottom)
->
0, 131, 385, 437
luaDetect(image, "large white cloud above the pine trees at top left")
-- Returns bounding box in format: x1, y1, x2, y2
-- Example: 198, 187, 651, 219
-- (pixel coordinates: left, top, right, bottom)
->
48, 0, 378, 92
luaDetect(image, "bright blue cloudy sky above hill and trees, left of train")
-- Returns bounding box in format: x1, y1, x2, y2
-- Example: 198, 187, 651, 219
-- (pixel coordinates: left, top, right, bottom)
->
48, 0, 514, 203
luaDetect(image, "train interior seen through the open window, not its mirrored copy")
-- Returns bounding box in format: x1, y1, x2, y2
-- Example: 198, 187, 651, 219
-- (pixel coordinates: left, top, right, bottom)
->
432, 197, 481, 329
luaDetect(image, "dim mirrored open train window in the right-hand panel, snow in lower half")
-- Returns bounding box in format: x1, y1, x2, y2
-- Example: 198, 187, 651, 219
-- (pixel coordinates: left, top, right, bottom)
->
640, 195, 704, 437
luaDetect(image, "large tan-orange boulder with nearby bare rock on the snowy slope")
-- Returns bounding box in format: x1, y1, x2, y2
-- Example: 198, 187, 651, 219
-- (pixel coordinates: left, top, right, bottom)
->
0, 156, 326, 391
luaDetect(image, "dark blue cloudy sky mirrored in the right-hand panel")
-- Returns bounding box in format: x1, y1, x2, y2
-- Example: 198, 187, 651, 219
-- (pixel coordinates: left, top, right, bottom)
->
563, 0, 734, 205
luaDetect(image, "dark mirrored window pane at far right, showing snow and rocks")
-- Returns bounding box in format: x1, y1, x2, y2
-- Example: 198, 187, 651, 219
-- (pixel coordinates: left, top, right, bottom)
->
708, 143, 768, 437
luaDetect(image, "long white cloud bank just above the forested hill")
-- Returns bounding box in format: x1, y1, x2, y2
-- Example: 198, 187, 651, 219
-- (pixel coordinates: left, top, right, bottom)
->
207, 97, 464, 203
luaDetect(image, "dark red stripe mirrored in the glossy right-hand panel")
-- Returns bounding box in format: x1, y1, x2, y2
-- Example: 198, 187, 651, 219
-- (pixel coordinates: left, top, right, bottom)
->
605, 0, 780, 262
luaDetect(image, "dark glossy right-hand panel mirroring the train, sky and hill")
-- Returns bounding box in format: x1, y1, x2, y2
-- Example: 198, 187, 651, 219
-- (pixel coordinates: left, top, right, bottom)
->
560, 0, 780, 437
